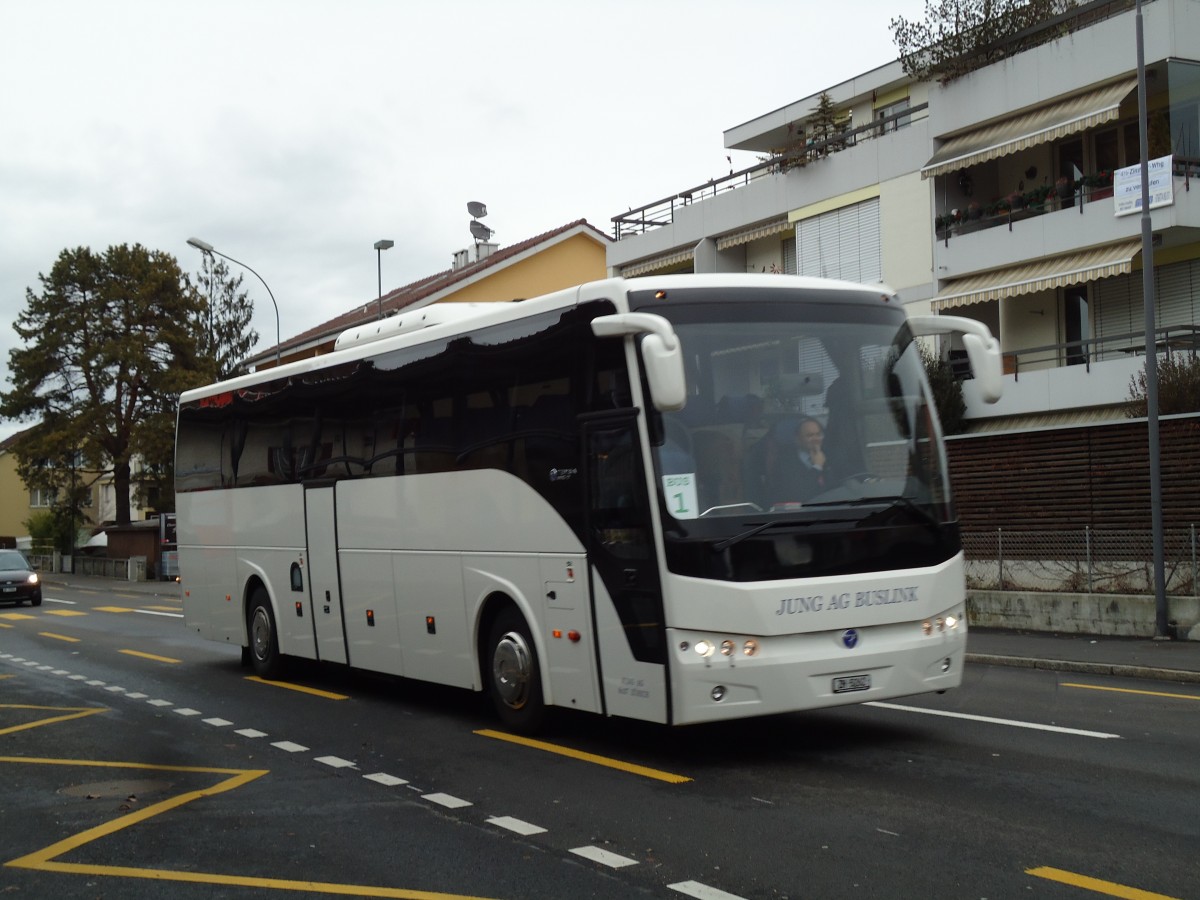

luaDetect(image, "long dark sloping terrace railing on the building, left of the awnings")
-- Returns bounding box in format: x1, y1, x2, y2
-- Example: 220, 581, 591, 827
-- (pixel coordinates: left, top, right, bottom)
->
612, 103, 929, 241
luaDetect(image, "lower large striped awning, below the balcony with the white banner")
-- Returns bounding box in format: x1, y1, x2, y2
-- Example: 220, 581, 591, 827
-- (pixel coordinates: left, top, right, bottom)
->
932, 240, 1141, 312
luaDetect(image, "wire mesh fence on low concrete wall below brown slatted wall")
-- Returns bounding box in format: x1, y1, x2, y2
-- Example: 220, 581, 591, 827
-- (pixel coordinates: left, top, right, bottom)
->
962, 524, 1198, 596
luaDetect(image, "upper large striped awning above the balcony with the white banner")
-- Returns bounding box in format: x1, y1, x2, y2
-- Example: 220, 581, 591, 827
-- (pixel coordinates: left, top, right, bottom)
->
920, 78, 1138, 178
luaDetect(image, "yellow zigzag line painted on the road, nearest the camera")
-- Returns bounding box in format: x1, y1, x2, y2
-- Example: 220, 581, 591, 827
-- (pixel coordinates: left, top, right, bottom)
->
0, 756, 492, 900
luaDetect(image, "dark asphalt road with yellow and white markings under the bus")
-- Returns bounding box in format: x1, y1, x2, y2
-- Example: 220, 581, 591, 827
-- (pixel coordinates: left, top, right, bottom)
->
0, 586, 1200, 900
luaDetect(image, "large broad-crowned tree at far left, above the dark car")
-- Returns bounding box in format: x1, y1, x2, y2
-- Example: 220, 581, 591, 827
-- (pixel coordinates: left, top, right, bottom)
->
0, 244, 203, 524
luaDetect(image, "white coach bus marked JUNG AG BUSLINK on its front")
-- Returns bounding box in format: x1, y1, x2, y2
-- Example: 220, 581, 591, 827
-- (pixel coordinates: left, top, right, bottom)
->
175, 275, 1001, 730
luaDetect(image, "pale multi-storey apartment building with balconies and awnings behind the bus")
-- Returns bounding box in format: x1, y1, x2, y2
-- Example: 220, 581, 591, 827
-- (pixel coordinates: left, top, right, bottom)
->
607, 0, 1200, 431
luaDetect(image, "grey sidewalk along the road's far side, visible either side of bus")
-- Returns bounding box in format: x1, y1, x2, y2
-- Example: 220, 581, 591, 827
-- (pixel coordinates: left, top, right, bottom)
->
44, 574, 1200, 684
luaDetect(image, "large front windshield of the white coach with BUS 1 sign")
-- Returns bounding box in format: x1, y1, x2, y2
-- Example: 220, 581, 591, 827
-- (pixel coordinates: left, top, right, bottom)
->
652, 292, 958, 580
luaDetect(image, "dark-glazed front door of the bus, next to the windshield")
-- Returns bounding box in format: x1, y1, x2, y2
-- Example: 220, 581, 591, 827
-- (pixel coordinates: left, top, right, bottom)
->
583, 409, 671, 722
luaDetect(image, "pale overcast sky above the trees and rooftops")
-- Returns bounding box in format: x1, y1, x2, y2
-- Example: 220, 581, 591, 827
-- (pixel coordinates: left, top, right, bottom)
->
0, 0, 924, 438
